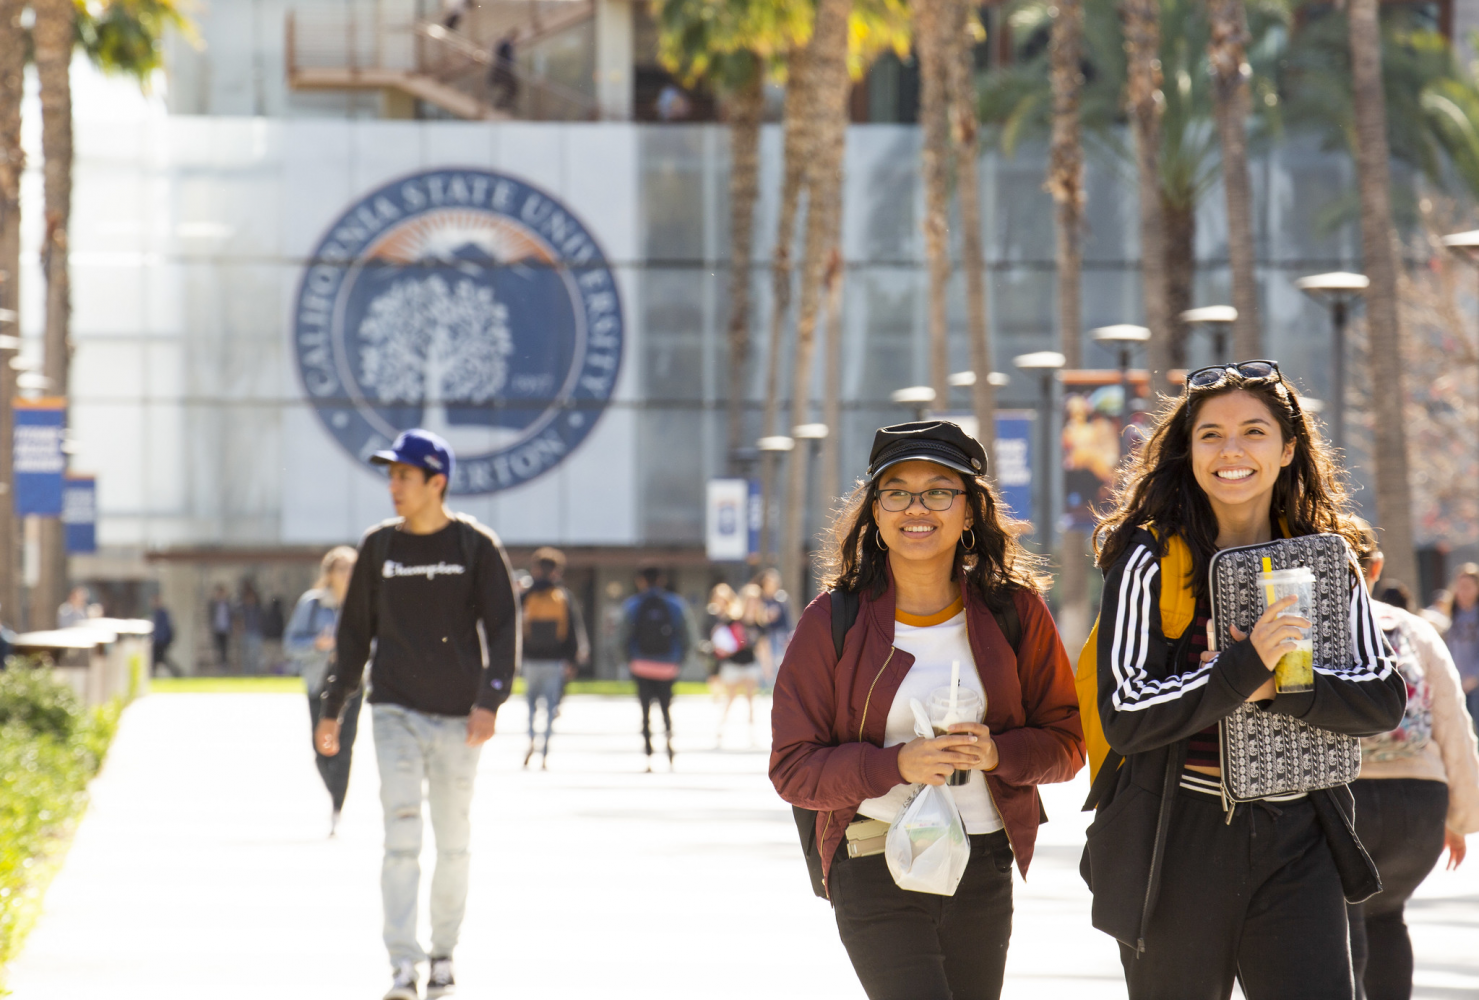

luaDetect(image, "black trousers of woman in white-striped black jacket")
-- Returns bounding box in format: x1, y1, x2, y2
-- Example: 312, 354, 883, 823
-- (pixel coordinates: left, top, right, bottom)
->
1120, 790, 1353, 1000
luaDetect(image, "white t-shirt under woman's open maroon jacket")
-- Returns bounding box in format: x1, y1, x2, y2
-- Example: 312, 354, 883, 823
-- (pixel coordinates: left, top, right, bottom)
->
858, 611, 1004, 833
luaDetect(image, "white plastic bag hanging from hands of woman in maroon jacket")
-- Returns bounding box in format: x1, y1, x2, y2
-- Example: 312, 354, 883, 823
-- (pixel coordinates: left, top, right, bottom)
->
883, 698, 970, 896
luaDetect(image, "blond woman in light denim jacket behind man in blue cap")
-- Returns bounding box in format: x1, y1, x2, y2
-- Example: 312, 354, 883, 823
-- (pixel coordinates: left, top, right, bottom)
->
282, 546, 364, 836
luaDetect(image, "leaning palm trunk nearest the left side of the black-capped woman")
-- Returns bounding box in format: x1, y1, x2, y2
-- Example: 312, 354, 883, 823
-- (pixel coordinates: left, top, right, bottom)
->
781, 0, 852, 609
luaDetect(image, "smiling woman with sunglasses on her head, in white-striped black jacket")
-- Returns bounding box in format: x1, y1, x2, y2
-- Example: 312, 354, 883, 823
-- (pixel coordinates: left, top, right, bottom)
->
1083, 361, 1407, 1000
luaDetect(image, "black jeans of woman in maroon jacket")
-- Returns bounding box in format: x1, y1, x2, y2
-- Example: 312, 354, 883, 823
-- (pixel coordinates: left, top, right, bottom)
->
827, 831, 1012, 1000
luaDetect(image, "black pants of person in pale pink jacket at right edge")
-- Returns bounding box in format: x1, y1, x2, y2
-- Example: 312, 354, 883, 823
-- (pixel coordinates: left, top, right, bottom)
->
1350, 778, 1448, 1000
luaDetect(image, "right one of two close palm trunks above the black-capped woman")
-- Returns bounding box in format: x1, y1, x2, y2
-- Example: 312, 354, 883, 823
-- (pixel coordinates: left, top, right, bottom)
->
936, 0, 997, 469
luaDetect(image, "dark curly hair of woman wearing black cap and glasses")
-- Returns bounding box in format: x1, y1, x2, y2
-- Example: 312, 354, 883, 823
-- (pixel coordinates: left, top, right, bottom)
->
818, 473, 1052, 611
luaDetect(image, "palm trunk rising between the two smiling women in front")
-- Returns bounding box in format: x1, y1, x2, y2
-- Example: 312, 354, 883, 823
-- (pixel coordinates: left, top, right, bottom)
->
1044, 0, 1093, 652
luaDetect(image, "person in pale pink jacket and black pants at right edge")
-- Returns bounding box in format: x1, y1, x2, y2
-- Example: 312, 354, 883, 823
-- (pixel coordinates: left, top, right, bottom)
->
1349, 522, 1479, 1000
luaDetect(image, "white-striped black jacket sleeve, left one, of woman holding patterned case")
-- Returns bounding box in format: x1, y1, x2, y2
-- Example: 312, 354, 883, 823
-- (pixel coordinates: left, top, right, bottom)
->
1109, 546, 1216, 712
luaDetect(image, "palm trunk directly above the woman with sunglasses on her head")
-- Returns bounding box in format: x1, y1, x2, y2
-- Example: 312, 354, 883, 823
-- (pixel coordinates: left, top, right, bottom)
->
1207, 0, 1263, 361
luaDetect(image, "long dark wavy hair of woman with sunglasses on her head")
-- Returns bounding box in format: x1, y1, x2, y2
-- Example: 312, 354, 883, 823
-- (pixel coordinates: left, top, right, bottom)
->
1093, 370, 1361, 601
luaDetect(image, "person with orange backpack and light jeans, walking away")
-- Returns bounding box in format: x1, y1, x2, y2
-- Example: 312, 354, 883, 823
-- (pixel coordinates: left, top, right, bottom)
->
521, 546, 590, 771
